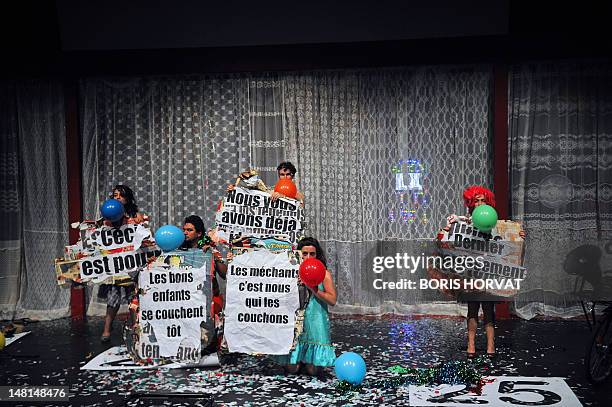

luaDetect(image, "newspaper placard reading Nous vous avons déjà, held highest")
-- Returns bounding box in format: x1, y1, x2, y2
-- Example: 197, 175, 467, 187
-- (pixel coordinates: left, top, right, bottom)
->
215, 187, 304, 243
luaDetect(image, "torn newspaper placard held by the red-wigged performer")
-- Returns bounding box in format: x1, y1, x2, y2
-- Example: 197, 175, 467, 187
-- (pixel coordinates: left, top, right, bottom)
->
434, 220, 527, 300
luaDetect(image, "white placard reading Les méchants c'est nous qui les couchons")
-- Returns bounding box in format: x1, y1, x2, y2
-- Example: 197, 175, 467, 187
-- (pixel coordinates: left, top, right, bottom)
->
224, 249, 300, 355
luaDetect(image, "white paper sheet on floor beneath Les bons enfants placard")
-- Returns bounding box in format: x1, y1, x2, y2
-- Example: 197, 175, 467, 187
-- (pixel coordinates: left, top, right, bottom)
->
81, 346, 220, 370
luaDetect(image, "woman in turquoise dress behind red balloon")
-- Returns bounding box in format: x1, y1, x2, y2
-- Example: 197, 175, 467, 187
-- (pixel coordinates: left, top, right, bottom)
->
274, 237, 336, 376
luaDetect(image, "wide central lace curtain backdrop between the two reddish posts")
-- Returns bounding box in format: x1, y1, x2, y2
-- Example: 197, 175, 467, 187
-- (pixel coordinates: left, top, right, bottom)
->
81, 66, 492, 313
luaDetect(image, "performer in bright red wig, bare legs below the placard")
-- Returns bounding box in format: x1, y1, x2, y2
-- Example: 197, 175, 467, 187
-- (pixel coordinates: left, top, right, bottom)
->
444, 186, 525, 358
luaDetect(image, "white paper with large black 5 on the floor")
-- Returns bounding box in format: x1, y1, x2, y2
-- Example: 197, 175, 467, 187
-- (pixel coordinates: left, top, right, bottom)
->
409, 376, 582, 407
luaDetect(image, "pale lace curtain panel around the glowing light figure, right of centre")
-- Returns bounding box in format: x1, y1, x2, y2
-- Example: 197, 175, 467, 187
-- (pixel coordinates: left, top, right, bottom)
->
284, 67, 492, 313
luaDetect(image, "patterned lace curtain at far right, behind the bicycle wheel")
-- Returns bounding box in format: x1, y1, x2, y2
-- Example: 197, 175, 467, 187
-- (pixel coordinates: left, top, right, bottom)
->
509, 61, 612, 318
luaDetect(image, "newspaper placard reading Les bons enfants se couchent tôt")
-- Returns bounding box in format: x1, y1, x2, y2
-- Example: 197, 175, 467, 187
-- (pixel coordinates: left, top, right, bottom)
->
135, 250, 211, 362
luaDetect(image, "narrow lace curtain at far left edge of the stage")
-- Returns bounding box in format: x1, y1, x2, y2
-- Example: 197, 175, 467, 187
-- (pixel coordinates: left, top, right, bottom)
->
0, 80, 69, 319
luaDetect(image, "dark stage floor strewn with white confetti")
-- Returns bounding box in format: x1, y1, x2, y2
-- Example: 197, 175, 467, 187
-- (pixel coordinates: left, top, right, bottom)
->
0, 318, 612, 406
